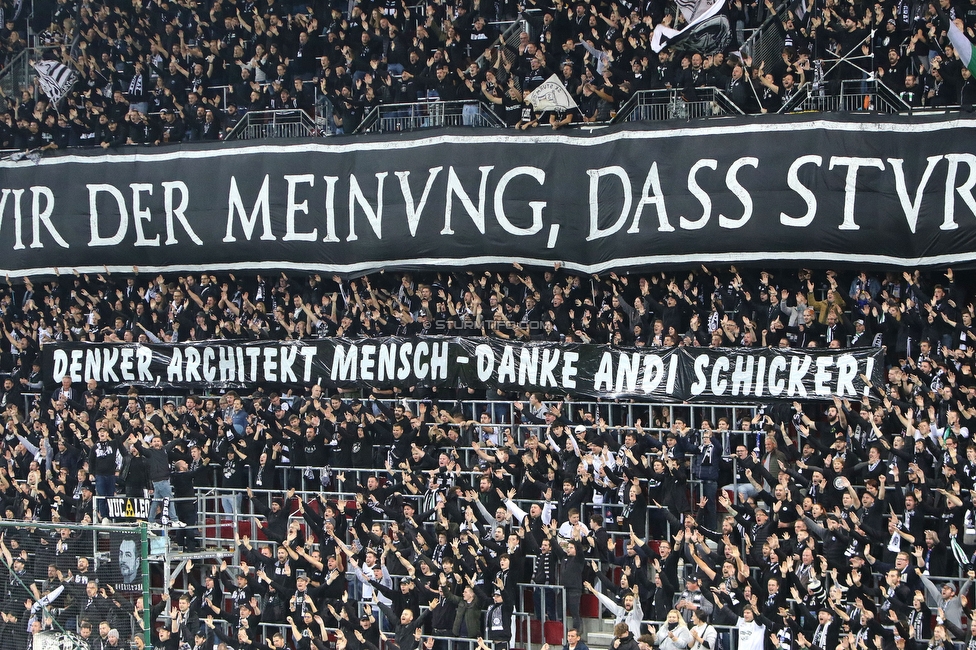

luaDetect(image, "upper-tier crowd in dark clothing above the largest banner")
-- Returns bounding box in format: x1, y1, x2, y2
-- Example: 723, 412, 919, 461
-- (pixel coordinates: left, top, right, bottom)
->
0, 0, 976, 150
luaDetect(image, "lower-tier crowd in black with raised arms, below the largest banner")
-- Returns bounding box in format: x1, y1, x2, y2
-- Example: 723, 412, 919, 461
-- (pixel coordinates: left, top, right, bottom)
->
0, 267, 976, 650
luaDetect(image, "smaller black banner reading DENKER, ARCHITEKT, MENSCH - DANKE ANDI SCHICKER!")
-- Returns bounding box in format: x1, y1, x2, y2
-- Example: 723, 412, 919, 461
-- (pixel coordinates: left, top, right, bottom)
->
43, 336, 883, 403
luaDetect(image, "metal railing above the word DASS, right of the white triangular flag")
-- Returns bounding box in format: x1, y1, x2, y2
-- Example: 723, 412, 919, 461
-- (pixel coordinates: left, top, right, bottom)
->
612, 86, 742, 124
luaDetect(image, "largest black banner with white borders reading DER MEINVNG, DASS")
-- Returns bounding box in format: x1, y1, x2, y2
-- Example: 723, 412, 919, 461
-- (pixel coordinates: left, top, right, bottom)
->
0, 115, 976, 275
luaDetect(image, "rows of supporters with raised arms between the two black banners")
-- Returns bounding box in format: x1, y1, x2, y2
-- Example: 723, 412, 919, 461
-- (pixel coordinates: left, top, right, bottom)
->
0, 264, 948, 370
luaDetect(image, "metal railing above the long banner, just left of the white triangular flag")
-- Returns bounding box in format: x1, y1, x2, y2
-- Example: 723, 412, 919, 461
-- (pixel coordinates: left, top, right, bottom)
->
354, 100, 505, 133
